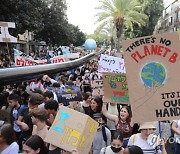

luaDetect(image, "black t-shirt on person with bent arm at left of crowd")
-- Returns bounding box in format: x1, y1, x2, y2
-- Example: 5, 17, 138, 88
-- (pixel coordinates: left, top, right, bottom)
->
21, 108, 33, 138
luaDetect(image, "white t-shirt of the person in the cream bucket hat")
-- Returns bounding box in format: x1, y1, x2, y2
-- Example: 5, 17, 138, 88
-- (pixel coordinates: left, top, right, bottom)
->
128, 133, 161, 154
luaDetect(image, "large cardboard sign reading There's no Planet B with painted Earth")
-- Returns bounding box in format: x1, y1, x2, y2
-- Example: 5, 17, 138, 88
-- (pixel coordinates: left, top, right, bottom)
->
123, 32, 180, 122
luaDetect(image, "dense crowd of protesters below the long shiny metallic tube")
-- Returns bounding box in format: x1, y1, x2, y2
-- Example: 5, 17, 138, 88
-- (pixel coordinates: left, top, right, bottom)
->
0, 48, 177, 154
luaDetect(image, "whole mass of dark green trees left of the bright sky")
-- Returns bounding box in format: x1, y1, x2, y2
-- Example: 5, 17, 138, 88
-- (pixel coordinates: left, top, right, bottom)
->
0, 0, 85, 45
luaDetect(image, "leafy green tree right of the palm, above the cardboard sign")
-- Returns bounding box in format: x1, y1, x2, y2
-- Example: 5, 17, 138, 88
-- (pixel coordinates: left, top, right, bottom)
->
124, 0, 163, 38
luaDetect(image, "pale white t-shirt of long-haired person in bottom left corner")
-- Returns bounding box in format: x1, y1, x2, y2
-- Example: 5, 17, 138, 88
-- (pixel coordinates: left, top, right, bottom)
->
1, 142, 19, 154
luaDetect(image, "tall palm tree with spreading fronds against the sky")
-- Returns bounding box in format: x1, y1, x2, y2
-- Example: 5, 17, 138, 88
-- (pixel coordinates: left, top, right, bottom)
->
96, 0, 148, 52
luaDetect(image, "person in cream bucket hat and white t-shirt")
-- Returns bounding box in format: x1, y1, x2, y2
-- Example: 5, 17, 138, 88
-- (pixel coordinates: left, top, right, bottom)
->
128, 122, 167, 154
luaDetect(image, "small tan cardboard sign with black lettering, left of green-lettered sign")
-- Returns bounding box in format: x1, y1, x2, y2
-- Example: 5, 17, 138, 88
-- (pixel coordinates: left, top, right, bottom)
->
91, 80, 104, 96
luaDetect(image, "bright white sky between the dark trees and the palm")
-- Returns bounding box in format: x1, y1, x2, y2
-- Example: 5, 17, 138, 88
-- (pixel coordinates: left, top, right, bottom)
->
66, 0, 99, 34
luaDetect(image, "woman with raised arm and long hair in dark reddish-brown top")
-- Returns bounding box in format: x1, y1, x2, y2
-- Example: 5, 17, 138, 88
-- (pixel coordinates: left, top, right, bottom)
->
102, 101, 133, 147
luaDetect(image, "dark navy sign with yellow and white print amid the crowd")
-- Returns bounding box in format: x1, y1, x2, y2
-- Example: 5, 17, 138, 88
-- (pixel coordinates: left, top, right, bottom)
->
57, 86, 82, 102
